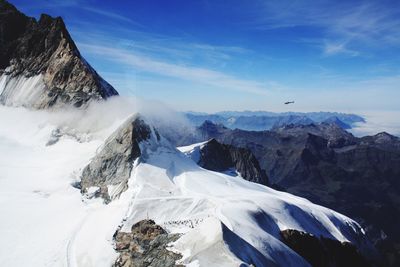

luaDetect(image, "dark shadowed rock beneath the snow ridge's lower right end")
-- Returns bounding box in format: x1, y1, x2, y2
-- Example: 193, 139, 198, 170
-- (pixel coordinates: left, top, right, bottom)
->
281, 229, 373, 267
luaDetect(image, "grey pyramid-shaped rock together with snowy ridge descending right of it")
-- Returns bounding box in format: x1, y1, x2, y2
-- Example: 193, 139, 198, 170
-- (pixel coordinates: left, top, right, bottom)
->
82, 116, 376, 267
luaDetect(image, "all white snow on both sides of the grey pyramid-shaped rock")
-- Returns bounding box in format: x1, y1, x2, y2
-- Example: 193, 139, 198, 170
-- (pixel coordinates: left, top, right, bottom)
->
0, 107, 363, 267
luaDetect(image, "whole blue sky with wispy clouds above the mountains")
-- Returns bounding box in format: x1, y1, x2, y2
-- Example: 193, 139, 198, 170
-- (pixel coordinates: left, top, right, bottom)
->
11, 0, 400, 113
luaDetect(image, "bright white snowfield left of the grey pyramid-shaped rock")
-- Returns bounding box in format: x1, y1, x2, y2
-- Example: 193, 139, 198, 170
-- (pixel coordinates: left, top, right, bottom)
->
0, 106, 130, 266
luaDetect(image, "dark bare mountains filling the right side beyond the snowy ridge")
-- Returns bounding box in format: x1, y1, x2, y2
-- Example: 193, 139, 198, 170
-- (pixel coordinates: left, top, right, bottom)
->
191, 123, 400, 266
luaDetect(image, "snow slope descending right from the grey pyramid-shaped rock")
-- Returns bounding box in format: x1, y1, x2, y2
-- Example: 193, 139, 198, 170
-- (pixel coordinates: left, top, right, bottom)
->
108, 127, 368, 266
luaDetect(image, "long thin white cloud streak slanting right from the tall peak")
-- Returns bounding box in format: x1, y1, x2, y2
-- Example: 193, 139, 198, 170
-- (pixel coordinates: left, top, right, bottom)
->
78, 43, 269, 95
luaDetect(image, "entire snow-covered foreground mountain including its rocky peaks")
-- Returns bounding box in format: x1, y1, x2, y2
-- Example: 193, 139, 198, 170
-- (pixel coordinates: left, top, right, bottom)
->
0, 0, 384, 267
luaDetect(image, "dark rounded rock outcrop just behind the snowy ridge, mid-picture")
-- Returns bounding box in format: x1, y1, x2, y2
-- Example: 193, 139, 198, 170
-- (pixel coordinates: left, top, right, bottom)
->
198, 139, 268, 185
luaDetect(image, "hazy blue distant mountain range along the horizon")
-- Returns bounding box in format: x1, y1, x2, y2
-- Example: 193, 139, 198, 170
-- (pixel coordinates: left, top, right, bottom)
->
185, 111, 365, 131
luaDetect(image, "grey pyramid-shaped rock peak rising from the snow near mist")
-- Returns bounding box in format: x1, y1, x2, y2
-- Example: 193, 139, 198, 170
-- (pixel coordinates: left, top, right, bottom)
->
81, 116, 151, 201
